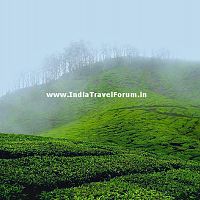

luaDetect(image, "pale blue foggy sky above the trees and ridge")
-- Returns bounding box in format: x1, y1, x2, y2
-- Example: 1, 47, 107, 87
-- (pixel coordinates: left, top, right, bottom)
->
0, 0, 200, 94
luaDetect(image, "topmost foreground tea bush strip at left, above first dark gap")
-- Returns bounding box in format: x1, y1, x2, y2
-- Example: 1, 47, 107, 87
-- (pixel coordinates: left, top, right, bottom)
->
0, 134, 114, 159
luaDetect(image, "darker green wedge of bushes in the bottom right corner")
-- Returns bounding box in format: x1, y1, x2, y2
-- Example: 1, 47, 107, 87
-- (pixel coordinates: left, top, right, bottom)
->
124, 169, 200, 200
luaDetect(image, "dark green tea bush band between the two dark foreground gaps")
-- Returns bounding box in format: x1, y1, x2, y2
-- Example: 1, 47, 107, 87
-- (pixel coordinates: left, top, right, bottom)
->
0, 154, 172, 198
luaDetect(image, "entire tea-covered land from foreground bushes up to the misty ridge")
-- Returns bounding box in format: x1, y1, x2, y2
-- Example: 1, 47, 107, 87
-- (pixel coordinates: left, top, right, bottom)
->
0, 58, 200, 200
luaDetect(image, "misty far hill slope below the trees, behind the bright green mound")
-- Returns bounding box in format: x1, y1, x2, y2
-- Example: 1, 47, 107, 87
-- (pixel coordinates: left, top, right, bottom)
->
0, 58, 200, 133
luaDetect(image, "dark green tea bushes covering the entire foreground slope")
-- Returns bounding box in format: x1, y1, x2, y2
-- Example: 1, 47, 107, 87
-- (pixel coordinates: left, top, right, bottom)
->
0, 134, 200, 199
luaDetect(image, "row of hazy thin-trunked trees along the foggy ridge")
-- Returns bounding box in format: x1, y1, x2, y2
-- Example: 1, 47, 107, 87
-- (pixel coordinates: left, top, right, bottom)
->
6, 41, 170, 94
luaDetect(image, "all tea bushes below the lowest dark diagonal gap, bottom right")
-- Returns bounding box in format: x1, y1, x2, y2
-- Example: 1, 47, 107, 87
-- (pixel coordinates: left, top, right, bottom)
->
40, 169, 200, 200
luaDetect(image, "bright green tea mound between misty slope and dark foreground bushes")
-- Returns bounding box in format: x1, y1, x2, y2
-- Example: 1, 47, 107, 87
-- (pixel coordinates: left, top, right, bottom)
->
45, 102, 200, 160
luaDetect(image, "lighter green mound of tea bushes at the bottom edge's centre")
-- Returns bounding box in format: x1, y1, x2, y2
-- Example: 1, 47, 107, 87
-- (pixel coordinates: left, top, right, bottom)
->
40, 180, 173, 200
